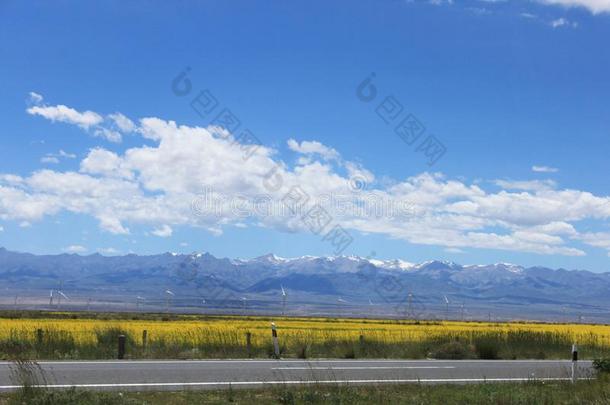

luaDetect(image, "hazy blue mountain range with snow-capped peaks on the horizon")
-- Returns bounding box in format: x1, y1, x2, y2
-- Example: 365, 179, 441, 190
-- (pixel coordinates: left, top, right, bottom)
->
0, 248, 610, 322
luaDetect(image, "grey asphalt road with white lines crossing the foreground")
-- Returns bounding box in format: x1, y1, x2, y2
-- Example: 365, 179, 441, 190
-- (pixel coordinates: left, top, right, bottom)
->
0, 360, 592, 391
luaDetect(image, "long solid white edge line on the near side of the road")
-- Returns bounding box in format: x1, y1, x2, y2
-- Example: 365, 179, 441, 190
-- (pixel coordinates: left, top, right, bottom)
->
0, 377, 589, 391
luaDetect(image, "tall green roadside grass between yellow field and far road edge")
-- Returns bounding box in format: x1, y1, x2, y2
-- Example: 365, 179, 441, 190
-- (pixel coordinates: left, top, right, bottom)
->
0, 327, 610, 360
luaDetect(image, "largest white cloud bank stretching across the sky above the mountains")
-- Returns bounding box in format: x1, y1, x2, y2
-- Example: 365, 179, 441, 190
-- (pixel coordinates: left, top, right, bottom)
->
8, 104, 610, 256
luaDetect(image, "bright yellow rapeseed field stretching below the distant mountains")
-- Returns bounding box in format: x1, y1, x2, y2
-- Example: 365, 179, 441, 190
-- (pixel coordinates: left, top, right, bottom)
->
0, 317, 610, 347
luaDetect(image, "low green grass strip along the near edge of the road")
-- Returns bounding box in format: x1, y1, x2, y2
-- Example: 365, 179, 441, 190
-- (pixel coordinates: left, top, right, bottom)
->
0, 375, 610, 405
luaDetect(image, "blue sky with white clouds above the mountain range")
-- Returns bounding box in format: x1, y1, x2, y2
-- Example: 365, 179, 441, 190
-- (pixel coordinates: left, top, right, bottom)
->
0, 0, 610, 271
